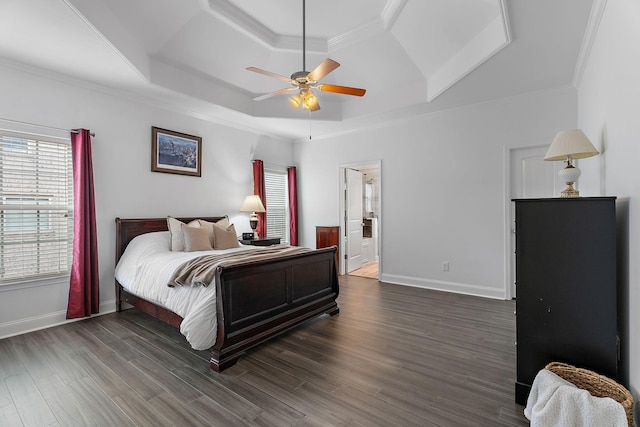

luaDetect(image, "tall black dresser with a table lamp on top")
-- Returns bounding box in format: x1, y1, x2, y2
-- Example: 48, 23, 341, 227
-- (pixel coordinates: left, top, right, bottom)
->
514, 197, 619, 405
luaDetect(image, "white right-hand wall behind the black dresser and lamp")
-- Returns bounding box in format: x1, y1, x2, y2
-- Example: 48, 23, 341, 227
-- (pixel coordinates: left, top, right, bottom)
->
578, 0, 640, 423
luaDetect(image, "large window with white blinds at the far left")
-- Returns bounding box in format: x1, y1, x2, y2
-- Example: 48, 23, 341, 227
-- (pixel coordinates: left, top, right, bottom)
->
0, 133, 73, 284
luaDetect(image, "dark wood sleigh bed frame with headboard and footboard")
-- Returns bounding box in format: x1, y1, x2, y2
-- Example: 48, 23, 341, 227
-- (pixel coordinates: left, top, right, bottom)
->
115, 217, 339, 372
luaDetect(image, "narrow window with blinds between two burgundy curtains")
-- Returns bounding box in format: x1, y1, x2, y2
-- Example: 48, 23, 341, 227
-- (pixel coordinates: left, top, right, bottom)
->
264, 169, 289, 244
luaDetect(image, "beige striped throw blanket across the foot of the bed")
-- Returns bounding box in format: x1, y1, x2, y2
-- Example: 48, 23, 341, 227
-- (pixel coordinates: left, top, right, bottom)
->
167, 245, 311, 288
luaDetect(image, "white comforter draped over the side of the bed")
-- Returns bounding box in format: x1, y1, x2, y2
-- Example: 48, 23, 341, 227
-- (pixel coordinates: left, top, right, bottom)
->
115, 231, 258, 350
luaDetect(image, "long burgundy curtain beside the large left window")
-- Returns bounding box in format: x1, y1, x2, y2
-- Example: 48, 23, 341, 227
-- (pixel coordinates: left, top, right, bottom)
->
67, 129, 100, 319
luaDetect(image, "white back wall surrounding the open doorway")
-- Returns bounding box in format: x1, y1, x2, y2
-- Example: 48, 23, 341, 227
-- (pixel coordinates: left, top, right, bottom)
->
294, 88, 576, 298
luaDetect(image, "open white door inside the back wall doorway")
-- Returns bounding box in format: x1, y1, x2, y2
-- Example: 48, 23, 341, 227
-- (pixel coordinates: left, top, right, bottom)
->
345, 169, 362, 273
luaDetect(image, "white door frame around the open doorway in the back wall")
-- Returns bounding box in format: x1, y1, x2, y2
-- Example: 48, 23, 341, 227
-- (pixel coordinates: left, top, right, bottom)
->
338, 160, 384, 277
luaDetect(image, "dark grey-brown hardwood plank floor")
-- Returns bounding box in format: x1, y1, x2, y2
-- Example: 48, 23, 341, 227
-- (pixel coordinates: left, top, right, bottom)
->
0, 276, 528, 427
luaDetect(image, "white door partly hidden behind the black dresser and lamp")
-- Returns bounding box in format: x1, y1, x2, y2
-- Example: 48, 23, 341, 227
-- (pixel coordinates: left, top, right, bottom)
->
509, 145, 566, 298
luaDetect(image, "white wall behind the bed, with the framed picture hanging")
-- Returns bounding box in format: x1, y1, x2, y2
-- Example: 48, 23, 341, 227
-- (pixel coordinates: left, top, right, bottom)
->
0, 63, 293, 337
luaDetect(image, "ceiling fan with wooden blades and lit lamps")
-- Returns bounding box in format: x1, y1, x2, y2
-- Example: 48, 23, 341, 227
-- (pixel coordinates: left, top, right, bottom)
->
247, 0, 366, 111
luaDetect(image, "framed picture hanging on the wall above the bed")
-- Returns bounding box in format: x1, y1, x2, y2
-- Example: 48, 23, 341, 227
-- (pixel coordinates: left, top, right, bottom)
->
151, 126, 202, 176
